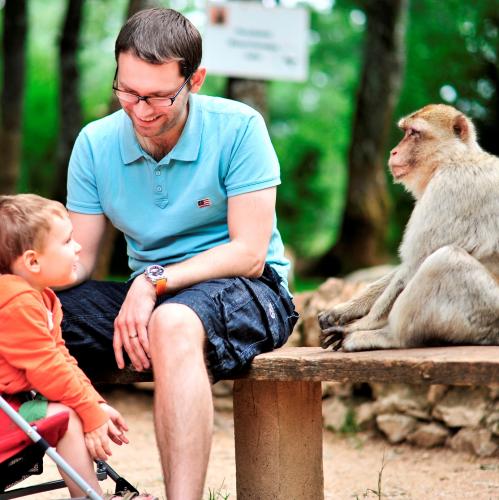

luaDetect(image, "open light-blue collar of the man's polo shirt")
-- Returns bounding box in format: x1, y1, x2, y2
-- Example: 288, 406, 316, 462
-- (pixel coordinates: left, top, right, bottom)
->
120, 94, 203, 165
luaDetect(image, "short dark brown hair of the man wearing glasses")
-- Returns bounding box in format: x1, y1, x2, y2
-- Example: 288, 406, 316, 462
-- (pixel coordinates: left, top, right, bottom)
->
114, 8, 203, 78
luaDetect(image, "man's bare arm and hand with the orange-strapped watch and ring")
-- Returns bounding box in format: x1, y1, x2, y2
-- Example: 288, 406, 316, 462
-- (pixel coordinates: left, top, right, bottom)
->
114, 187, 276, 370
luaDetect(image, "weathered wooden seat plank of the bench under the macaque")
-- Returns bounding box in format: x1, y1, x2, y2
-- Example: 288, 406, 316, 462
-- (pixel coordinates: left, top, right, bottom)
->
236, 346, 499, 385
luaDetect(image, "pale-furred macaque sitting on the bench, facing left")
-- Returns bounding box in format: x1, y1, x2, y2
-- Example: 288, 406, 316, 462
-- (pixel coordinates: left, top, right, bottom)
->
319, 104, 499, 351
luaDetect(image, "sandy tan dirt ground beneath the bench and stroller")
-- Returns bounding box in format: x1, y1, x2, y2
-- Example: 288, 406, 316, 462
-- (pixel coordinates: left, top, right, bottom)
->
23, 389, 499, 500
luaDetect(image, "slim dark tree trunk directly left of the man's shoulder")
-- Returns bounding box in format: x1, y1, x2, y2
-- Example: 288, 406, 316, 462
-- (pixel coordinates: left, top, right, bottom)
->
53, 0, 83, 203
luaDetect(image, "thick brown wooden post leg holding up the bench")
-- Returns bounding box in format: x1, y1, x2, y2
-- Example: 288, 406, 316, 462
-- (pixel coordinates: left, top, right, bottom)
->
234, 380, 324, 500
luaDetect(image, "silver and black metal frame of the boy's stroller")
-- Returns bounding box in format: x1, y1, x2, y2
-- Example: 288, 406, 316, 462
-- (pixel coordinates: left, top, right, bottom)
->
0, 395, 139, 500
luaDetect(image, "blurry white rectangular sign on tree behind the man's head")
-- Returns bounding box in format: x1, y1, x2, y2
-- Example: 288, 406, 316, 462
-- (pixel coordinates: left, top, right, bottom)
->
203, 1, 309, 81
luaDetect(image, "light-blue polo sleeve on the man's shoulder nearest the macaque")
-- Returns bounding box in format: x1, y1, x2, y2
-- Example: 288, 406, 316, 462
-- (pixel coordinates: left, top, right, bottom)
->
225, 113, 281, 197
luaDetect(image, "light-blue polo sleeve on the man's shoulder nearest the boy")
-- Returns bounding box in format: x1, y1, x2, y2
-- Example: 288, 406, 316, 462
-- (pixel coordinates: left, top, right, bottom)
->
67, 129, 103, 214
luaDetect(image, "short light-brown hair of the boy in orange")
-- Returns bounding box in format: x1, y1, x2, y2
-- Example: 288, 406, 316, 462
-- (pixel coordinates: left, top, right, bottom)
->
0, 194, 68, 274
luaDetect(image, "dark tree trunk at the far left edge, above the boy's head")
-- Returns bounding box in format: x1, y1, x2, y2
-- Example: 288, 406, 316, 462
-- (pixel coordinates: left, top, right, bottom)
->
0, 0, 27, 194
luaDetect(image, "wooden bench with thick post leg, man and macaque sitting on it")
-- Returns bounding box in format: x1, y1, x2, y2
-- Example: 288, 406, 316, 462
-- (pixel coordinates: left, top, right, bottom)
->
94, 346, 499, 500
